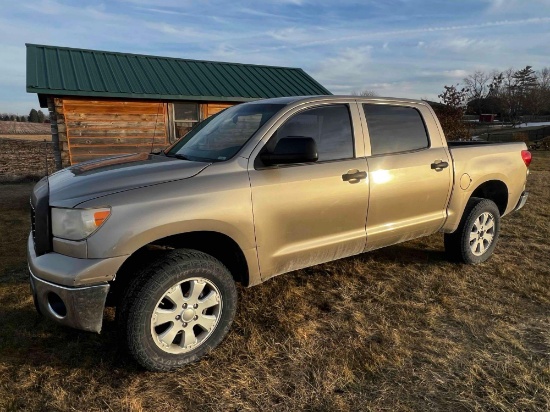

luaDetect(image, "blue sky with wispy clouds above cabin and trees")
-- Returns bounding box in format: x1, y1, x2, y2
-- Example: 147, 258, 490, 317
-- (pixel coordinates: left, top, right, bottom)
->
0, 0, 550, 114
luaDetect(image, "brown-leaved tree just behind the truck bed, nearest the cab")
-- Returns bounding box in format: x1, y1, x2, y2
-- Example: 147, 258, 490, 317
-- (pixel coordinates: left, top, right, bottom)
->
434, 84, 470, 140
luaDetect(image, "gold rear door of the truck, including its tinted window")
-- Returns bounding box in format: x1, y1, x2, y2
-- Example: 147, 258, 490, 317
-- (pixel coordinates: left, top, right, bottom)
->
362, 103, 452, 250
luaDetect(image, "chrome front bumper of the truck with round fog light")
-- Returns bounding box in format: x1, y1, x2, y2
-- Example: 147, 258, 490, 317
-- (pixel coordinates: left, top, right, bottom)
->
30, 272, 109, 333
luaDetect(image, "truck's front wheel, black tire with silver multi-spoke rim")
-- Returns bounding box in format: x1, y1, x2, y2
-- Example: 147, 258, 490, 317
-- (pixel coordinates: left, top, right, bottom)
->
117, 249, 237, 371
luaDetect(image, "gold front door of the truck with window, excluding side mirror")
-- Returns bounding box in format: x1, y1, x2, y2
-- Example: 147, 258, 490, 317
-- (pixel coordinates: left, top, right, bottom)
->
248, 100, 369, 280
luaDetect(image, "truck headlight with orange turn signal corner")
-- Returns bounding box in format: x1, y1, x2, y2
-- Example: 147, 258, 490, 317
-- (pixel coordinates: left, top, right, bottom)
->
52, 207, 111, 240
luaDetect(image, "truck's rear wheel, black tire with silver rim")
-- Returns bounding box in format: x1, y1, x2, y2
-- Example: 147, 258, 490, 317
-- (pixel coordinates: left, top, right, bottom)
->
444, 197, 500, 265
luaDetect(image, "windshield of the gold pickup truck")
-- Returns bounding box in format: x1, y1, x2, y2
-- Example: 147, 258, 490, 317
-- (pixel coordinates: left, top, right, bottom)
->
166, 103, 285, 162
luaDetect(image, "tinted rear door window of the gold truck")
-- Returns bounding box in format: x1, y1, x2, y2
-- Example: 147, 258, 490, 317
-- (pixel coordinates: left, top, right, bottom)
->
363, 104, 430, 155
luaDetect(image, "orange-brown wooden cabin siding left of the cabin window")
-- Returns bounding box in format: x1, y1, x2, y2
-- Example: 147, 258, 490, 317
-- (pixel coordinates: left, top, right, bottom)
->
62, 98, 169, 164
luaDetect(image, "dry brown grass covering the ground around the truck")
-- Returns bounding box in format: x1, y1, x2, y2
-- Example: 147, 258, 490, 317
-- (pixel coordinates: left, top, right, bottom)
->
0, 152, 550, 411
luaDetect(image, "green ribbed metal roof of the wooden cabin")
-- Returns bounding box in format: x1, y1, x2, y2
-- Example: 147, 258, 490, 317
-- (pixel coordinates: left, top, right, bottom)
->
26, 44, 331, 101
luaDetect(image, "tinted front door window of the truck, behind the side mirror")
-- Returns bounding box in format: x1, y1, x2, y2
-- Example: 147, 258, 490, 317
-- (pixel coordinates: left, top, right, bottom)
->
270, 105, 354, 162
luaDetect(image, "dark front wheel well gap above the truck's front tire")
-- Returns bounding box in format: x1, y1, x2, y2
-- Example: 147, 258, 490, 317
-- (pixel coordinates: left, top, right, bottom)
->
107, 232, 249, 306
